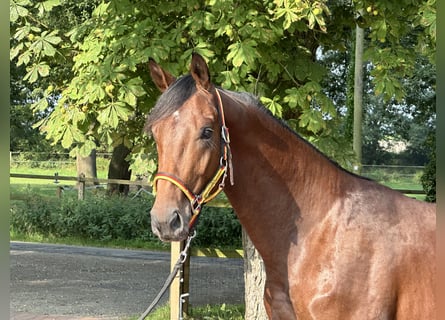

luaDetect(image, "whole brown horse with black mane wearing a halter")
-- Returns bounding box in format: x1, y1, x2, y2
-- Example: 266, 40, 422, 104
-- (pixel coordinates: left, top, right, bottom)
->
146, 54, 436, 320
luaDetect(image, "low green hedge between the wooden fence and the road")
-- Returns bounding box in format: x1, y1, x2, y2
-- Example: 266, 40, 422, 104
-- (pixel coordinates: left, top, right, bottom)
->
10, 194, 241, 247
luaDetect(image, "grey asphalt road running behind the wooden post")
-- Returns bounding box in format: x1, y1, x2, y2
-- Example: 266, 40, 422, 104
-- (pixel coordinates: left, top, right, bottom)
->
10, 242, 244, 318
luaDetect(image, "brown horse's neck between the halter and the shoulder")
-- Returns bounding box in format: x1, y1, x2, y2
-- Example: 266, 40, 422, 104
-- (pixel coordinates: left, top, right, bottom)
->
223, 93, 347, 258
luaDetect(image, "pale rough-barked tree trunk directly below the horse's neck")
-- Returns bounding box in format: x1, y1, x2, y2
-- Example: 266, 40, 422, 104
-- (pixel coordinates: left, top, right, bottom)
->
243, 229, 268, 320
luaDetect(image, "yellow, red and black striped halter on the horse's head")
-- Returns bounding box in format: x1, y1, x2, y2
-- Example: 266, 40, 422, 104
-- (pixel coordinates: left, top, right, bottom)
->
153, 89, 234, 230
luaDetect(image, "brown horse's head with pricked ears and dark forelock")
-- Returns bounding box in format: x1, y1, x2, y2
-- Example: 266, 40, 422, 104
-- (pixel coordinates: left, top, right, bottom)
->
146, 54, 225, 241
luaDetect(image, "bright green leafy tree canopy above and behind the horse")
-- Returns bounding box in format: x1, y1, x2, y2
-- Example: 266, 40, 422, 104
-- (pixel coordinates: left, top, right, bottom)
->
10, 0, 436, 174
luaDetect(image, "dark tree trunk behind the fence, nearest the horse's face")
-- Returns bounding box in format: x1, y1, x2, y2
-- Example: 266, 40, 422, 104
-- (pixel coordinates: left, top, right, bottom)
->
108, 144, 131, 195
